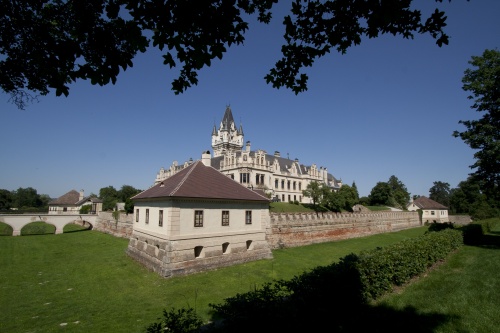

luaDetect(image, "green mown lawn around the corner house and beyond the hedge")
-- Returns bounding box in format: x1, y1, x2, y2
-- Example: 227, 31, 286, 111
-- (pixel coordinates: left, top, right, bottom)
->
0, 218, 500, 333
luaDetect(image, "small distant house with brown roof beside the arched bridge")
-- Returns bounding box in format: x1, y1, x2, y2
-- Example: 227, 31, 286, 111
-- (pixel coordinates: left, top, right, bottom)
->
49, 190, 102, 214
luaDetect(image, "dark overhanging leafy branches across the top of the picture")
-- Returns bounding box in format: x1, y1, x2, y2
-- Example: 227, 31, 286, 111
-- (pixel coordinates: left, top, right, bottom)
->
0, 0, 448, 108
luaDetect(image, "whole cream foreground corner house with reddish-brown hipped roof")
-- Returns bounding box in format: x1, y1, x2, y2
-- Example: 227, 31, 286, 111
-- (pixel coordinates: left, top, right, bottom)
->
127, 159, 272, 277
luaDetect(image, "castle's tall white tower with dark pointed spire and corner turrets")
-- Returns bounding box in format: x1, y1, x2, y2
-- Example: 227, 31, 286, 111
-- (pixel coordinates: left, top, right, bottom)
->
212, 106, 243, 157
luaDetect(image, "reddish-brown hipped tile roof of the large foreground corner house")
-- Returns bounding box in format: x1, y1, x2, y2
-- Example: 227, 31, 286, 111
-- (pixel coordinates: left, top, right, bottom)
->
132, 161, 269, 201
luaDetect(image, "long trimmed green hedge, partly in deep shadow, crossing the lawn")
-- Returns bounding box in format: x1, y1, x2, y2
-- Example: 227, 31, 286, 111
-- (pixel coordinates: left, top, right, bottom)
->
147, 229, 463, 333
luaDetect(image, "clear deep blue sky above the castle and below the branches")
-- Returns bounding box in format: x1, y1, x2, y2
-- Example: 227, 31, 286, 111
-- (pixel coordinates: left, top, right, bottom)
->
0, 0, 500, 198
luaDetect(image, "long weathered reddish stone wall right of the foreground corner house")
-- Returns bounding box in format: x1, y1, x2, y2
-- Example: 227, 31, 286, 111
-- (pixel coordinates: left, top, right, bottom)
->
267, 212, 422, 249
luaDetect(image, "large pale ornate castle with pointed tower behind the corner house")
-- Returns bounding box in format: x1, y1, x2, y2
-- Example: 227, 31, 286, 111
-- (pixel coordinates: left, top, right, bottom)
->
155, 106, 342, 203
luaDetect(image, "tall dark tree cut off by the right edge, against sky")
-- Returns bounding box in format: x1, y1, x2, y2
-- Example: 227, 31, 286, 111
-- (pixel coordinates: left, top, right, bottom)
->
453, 50, 500, 205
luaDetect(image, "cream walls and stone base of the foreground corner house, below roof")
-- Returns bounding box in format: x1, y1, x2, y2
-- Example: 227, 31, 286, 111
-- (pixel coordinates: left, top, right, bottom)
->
127, 200, 272, 277
